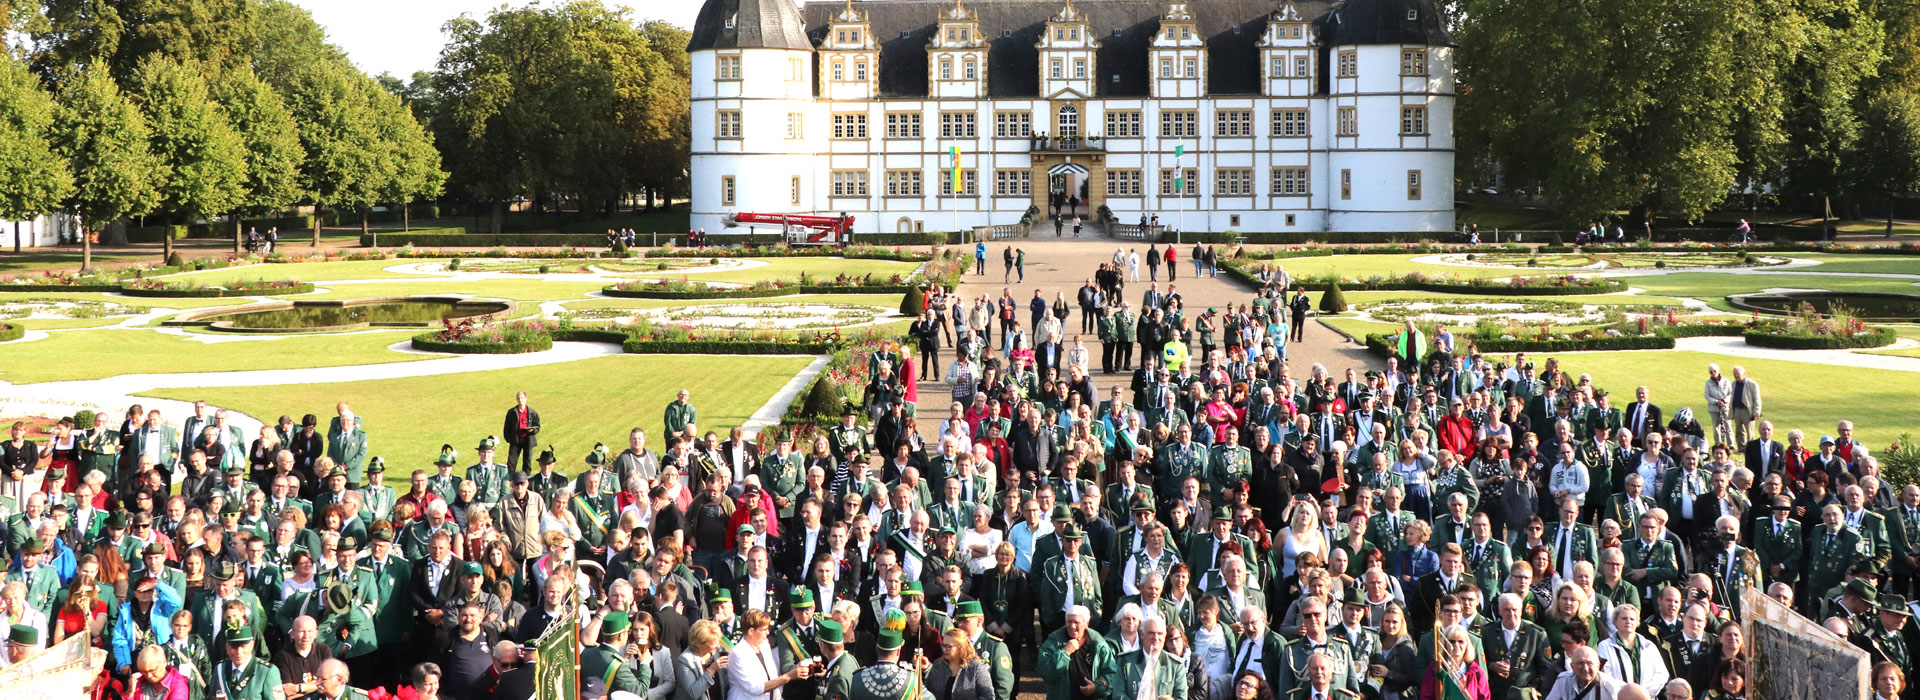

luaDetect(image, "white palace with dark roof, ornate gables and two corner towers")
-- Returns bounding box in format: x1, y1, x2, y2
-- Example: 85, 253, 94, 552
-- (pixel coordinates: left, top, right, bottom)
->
689, 0, 1453, 232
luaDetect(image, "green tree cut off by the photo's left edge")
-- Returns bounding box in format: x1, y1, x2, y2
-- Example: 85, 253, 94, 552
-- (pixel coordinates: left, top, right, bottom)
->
0, 54, 73, 253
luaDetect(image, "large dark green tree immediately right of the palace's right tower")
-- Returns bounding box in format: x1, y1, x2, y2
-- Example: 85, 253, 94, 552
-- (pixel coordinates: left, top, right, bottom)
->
1455, 0, 1805, 219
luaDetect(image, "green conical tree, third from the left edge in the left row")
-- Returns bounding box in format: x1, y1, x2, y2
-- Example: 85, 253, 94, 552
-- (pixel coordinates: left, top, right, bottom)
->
136, 54, 248, 255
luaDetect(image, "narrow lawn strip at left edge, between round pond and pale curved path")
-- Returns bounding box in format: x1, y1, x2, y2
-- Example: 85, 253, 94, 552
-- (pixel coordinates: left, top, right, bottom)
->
0, 328, 432, 384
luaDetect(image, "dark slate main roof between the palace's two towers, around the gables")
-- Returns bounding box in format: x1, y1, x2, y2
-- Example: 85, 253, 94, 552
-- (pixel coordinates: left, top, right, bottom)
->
794, 0, 1336, 98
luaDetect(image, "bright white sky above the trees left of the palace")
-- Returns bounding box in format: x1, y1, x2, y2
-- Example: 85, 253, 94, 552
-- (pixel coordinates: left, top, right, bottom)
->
294, 0, 701, 77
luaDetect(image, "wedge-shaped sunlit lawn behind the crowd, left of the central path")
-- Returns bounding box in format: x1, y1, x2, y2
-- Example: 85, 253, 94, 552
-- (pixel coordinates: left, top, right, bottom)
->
154, 355, 810, 489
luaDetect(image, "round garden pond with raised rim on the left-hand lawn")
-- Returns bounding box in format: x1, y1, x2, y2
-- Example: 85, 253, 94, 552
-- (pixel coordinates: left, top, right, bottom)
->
167, 297, 513, 327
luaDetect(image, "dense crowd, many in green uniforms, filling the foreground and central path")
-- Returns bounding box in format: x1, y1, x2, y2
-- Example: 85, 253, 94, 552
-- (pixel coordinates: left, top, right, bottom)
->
0, 244, 1920, 700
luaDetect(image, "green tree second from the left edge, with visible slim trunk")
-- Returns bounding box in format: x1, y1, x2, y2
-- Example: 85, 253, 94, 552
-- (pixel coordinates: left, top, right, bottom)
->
54, 65, 167, 270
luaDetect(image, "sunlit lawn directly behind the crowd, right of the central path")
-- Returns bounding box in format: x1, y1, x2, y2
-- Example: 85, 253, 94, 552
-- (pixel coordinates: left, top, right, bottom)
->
1536, 351, 1920, 449
